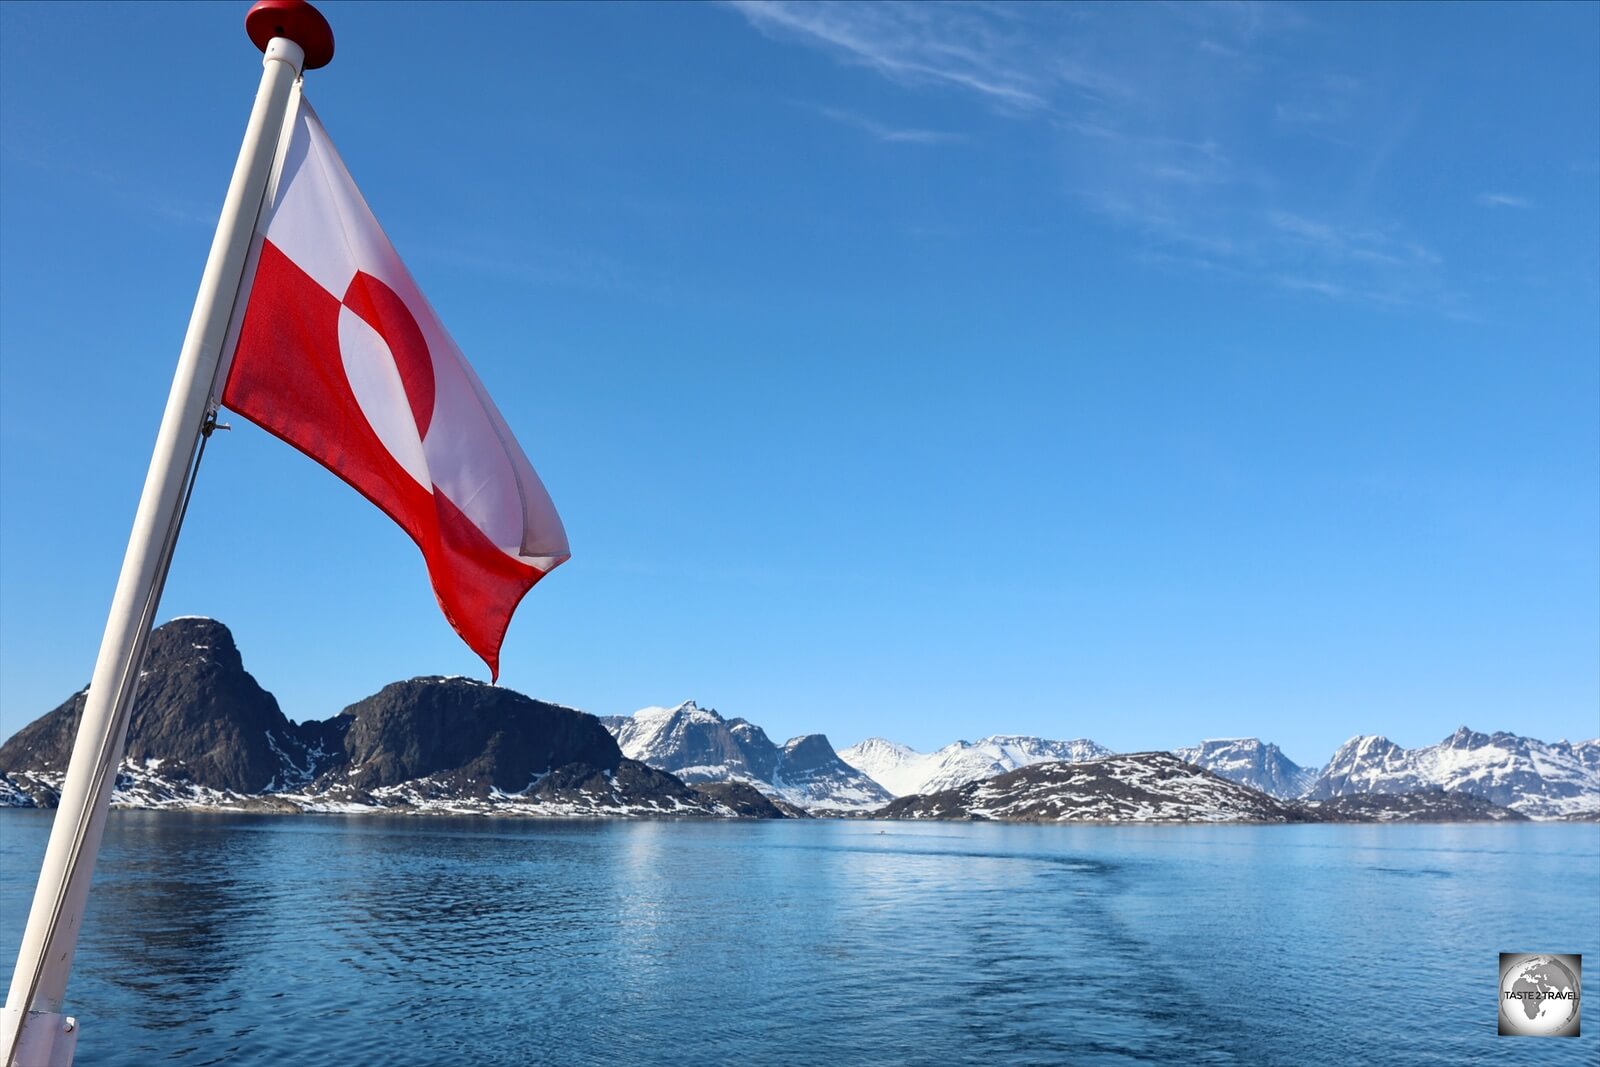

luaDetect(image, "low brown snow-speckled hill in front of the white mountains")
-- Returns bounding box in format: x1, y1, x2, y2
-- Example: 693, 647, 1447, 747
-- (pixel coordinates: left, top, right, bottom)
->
880, 752, 1309, 822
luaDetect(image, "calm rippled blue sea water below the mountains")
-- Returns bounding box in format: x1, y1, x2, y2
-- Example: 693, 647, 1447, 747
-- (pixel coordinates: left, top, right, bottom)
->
0, 813, 1600, 1067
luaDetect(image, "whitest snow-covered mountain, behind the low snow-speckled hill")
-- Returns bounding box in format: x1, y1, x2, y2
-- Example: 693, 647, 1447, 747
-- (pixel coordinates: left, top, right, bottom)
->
838, 734, 1110, 797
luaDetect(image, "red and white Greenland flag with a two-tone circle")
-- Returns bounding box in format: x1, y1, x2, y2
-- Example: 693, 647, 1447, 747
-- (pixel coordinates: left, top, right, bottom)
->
218, 91, 570, 678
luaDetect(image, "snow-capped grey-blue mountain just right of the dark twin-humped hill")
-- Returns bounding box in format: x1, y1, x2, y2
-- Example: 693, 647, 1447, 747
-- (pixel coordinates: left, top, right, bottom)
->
602, 701, 891, 808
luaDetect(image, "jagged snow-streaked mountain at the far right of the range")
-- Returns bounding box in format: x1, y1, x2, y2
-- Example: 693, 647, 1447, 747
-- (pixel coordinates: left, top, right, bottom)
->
1306, 726, 1600, 819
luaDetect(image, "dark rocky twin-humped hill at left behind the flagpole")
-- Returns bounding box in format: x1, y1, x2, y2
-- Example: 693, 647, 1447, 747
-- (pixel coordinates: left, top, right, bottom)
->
0, 619, 768, 817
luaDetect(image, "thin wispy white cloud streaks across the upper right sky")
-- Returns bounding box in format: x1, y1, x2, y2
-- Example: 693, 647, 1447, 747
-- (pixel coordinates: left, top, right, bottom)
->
728, 0, 1465, 315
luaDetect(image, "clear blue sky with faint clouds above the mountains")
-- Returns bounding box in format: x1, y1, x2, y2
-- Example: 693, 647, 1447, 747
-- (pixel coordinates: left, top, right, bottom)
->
0, 0, 1600, 763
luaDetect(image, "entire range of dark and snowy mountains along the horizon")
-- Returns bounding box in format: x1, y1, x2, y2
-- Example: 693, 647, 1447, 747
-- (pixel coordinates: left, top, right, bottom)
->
0, 617, 1600, 821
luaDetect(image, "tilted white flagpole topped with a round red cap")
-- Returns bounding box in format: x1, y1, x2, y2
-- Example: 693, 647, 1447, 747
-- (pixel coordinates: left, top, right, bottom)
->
0, 0, 333, 1067
